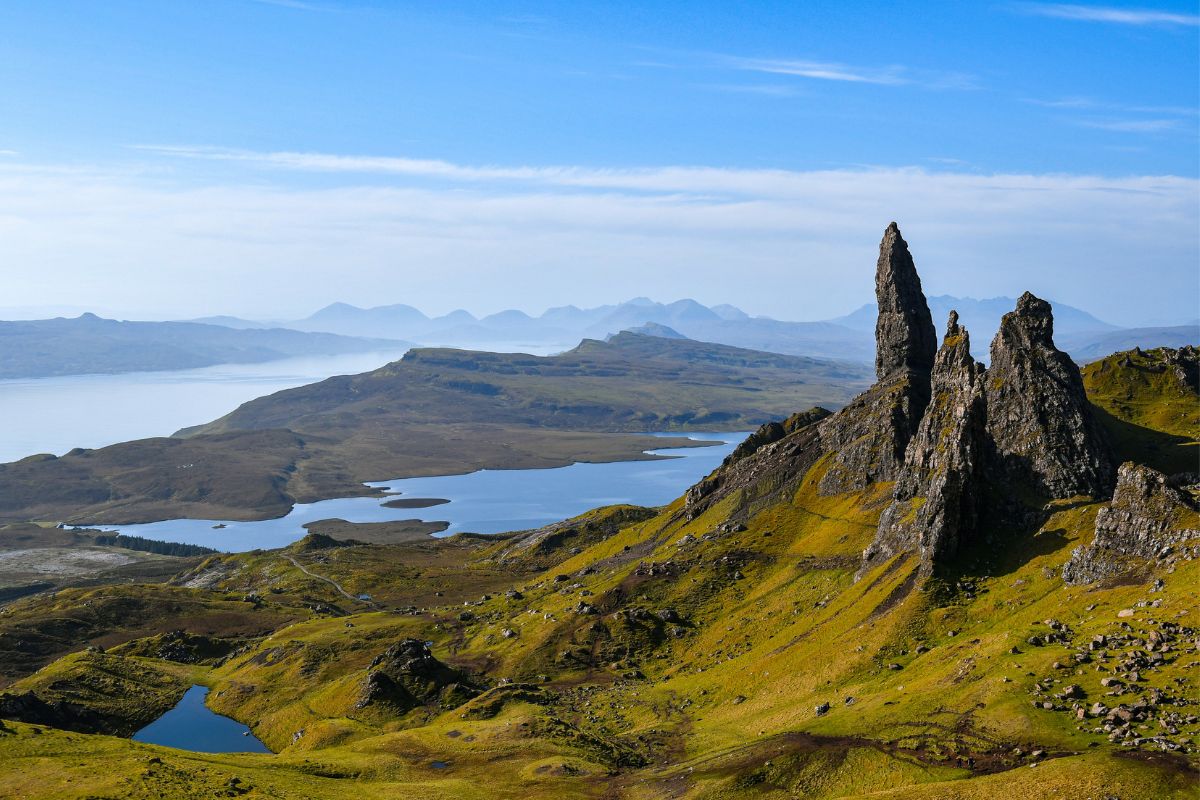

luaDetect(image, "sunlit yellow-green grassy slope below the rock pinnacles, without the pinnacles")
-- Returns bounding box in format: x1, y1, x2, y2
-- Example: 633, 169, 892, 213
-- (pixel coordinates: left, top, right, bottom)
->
0, 347, 1200, 799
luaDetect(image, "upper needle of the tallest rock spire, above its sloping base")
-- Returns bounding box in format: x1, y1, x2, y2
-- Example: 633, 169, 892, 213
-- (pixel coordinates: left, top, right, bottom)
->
875, 222, 937, 380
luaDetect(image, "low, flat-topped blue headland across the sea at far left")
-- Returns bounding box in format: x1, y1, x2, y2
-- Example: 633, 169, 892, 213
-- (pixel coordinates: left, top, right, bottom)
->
0, 314, 409, 379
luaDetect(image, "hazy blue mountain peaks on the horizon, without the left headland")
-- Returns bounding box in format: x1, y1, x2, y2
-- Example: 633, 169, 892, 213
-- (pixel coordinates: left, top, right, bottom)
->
194, 295, 1200, 362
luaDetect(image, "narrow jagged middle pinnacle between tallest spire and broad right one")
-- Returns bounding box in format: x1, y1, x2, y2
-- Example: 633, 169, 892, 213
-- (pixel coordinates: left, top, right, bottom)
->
859, 312, 986, 576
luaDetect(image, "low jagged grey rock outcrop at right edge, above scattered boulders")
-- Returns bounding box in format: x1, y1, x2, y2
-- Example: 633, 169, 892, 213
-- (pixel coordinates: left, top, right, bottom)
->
1062, 462, 1200, 584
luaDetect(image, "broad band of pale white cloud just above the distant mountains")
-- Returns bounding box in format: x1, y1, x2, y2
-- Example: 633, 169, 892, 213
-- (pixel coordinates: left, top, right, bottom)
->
0, 154, 1200, 321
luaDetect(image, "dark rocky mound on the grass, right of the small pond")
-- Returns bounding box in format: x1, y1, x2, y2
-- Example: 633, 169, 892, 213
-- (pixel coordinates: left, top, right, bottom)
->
355, 639, 479, 712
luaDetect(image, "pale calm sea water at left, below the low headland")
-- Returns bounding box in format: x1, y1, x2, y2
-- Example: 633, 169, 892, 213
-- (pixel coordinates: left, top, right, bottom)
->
0, 350, 403, 462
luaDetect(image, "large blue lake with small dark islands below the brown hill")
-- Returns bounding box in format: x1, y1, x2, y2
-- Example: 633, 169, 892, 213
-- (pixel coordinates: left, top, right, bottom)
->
87, 433, 748, 552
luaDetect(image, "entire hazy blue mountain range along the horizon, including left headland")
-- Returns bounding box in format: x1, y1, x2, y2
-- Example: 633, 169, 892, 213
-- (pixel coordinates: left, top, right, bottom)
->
0, 295, 1200, 379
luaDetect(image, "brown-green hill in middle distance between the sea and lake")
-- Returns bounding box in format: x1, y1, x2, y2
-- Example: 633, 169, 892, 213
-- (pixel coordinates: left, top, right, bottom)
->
0, 333, 866, 523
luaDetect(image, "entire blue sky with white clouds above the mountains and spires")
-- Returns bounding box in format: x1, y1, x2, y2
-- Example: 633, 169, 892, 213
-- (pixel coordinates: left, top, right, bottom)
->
0, 0, 1200, 325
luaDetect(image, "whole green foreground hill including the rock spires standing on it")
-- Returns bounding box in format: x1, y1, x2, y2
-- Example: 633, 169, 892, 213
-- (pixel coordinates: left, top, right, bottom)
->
0, 225, 1200, 800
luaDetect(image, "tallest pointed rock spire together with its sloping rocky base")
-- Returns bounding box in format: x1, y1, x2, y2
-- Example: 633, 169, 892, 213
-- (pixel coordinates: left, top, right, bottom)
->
821, 222, 937, 494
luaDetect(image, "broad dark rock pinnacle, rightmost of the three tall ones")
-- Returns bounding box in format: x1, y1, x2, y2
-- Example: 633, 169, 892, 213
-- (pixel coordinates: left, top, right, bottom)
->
988, 291, 1114, 498
